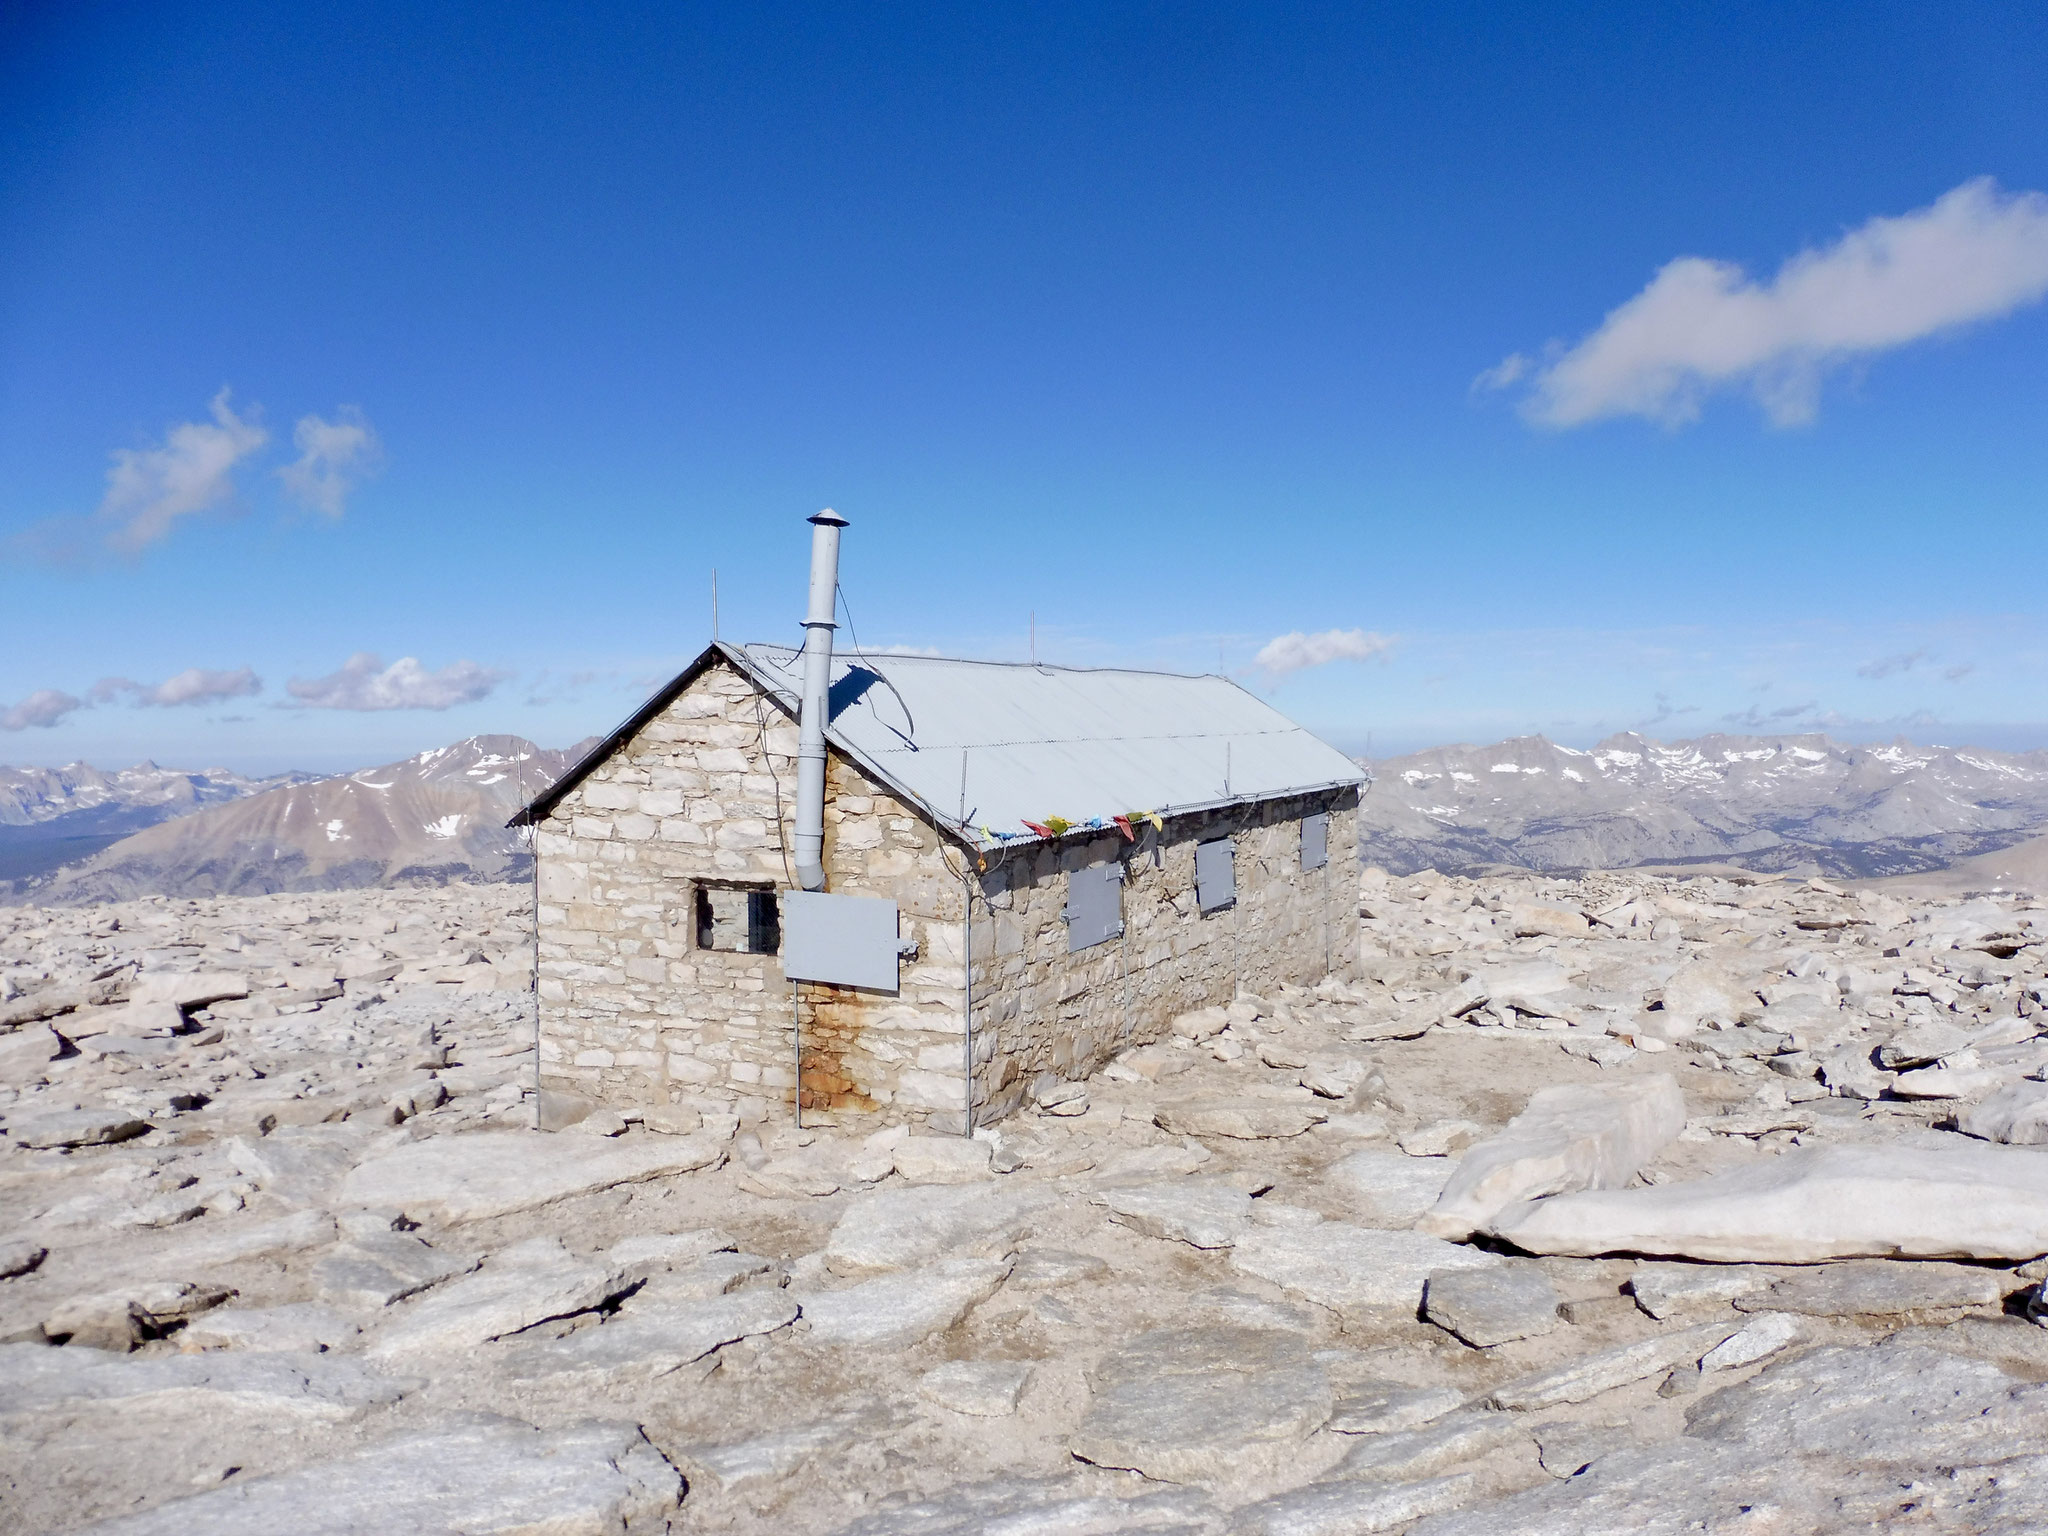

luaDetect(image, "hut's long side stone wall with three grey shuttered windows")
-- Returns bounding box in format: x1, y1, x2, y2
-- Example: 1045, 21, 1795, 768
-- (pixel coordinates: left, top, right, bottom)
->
973, 788, 1358, 1122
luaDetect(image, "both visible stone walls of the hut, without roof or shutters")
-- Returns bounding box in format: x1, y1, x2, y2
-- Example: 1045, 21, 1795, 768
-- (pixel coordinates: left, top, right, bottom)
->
537, 662, 1358, 1128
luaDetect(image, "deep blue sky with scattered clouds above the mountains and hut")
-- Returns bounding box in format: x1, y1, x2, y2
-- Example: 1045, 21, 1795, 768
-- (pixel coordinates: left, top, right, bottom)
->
0, 4, 2048, 770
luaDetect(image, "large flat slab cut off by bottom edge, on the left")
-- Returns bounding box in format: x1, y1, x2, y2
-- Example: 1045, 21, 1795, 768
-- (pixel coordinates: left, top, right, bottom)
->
70, 1419, 682, 1536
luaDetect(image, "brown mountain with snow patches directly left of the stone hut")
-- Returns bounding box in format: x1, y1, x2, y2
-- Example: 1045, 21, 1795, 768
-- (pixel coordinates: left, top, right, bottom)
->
12, 735, 590, 903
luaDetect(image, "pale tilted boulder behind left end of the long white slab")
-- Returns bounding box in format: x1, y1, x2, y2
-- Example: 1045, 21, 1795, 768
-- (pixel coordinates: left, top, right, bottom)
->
1419, 1073, 1686, 1239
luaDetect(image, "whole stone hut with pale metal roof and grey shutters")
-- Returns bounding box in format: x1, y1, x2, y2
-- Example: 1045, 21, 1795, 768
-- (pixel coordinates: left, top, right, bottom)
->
514, 643, 1364, 1130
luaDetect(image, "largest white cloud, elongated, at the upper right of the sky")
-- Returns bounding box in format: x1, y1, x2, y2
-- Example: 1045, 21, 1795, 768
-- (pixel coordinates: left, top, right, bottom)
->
1475, 178, 2048, 426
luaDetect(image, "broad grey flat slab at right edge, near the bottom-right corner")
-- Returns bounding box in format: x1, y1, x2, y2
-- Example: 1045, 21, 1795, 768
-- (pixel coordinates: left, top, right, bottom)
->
1686, 1346, 2048, 1468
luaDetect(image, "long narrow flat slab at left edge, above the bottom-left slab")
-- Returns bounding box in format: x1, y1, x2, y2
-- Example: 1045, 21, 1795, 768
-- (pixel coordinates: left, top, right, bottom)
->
0, 1343, 416, 1419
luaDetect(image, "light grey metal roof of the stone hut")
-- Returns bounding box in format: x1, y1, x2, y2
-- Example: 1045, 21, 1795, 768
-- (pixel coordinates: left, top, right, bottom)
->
719, 645, 1364, 846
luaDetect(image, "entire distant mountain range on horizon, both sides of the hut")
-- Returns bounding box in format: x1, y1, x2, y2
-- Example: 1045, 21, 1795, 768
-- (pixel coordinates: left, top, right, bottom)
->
12, 733, 2048, 903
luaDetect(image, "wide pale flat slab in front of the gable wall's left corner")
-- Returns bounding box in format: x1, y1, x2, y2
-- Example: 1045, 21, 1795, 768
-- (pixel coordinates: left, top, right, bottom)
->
342, 1130, 725, 1221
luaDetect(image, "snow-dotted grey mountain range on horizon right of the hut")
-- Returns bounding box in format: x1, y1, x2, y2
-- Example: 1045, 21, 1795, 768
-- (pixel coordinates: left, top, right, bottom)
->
1360, 733, 2048, 879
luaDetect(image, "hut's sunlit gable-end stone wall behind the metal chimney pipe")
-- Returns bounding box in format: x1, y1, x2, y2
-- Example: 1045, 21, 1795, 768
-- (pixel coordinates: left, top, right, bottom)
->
537, 662, 965, 1120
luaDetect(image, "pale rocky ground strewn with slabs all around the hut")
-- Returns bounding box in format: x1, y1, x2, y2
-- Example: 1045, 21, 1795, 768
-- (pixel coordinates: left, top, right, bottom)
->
0, 872, 2048, 1536
